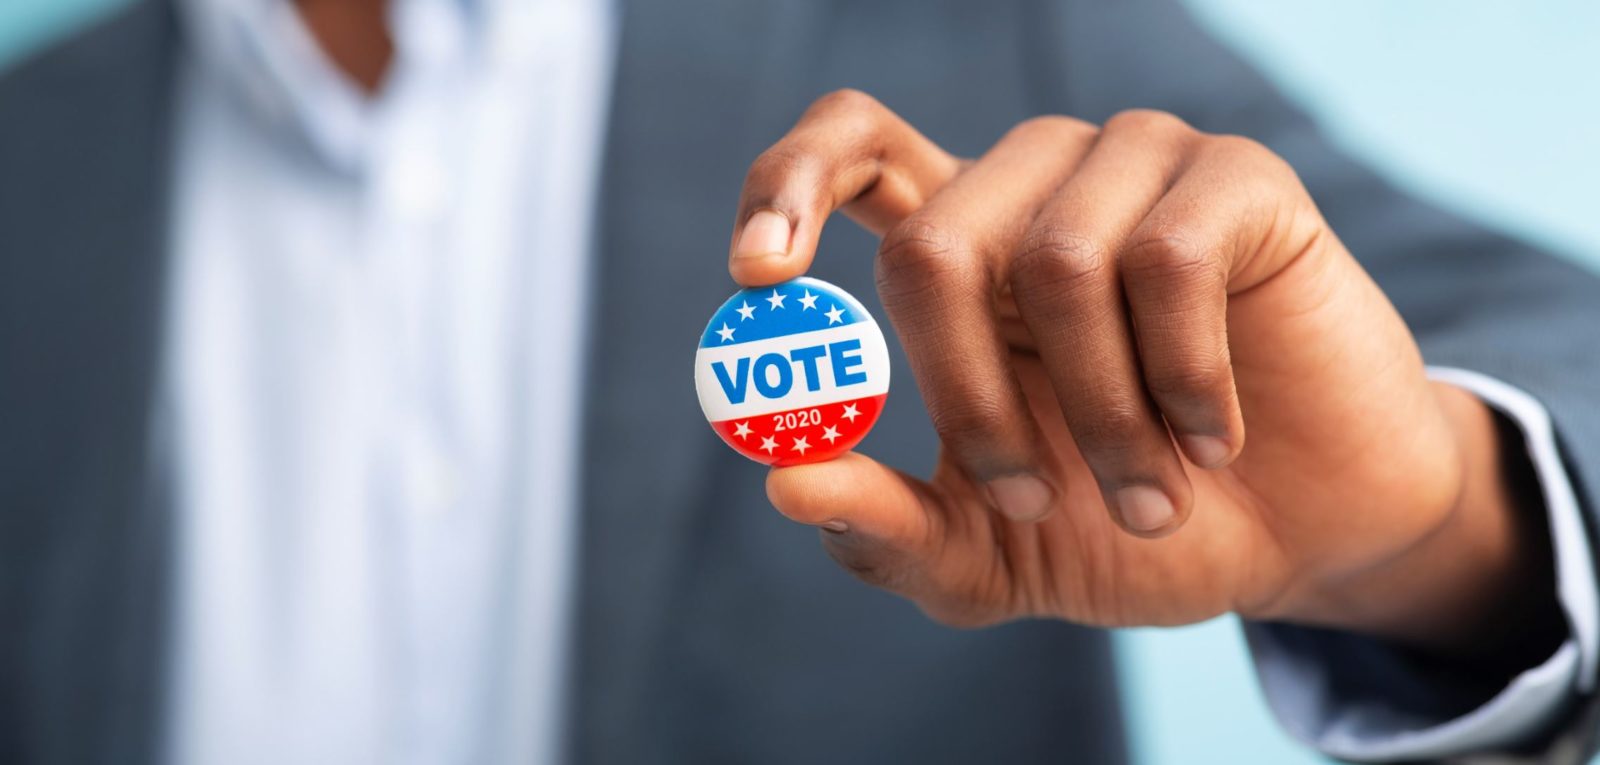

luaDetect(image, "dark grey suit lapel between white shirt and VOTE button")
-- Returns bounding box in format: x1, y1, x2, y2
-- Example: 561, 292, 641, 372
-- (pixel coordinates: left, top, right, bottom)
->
571, 0, 814, 762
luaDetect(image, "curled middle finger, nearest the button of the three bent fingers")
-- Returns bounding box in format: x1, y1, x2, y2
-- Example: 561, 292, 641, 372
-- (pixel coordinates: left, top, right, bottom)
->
878, 117, 1096, 520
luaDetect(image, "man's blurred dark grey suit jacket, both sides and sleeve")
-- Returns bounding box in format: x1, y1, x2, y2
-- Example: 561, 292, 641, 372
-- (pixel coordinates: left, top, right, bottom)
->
0, 0, 1600, 763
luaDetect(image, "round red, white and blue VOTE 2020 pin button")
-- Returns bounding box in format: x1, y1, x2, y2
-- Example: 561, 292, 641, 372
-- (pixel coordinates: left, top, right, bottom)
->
694, 277, 890, 467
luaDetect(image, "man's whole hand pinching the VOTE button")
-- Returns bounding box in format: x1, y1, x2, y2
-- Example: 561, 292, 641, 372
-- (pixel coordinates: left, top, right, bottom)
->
730, 91, 1547, 648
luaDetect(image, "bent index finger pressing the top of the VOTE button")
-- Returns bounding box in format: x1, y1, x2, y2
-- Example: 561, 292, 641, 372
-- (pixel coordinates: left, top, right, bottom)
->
728, 90, 962, 286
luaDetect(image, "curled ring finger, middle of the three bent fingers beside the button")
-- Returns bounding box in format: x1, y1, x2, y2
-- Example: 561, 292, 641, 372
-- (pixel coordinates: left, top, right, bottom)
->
1011, 112, 1195, 536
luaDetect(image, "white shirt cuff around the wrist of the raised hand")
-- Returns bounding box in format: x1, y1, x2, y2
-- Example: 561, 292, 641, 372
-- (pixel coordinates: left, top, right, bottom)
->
1245, 366, 1600, 762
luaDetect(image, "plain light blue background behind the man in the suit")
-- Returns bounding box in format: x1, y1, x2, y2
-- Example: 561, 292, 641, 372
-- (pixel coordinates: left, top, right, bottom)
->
0, 0, 1600, 765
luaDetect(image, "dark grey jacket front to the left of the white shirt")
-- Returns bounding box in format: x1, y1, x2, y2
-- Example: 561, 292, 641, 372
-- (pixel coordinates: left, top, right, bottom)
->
0, 2, 174, 762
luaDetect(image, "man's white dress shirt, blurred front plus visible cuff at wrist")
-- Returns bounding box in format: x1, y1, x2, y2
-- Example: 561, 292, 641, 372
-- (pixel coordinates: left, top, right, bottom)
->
165, 0, 1597, 763
